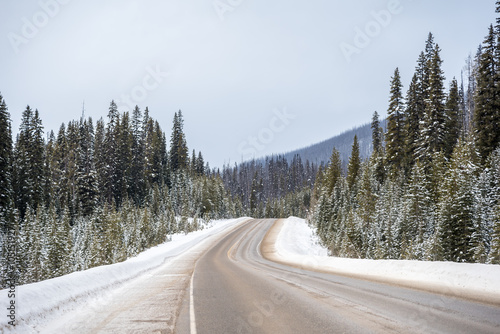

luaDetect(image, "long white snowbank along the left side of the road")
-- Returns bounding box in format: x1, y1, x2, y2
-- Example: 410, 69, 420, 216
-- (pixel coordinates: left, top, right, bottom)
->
0, 218, 248, 332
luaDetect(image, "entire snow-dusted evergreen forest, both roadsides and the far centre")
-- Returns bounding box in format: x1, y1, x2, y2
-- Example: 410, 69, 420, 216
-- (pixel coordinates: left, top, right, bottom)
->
0, 1, 500, 288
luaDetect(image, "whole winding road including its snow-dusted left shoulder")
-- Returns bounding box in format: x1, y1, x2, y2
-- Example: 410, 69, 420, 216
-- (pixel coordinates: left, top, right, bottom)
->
43, 219, 500, 334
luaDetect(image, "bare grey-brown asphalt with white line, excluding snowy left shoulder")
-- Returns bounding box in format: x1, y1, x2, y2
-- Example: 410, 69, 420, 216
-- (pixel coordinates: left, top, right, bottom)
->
176, 219, 500, 334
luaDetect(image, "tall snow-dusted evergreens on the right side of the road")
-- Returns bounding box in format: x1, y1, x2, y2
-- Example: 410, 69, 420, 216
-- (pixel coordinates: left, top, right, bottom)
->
310, 13, 500, 264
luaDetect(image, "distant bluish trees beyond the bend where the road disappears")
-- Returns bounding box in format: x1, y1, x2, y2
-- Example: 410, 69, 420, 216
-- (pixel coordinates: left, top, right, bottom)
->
222, 155, 318, 218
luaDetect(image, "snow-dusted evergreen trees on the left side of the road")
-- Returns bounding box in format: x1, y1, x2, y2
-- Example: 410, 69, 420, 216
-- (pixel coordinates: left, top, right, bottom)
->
0, 100, 235, 286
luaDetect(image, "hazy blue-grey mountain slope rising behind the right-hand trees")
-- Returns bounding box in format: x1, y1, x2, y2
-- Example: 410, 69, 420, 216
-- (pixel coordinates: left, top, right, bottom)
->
284, 120, 385, 165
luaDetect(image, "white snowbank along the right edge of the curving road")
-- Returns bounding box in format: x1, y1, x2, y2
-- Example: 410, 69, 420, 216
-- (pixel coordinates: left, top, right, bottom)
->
275, 217, 500, 304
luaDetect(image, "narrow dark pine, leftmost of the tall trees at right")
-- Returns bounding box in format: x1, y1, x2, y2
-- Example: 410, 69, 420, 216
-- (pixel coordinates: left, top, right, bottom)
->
386, 68, 405, 173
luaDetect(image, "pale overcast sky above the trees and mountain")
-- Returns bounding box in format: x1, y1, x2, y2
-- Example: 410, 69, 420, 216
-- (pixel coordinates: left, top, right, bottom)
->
0, 0, 496, 167
